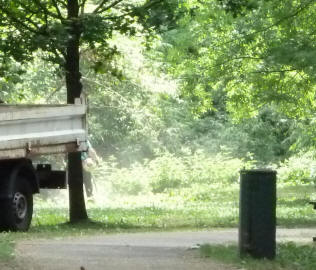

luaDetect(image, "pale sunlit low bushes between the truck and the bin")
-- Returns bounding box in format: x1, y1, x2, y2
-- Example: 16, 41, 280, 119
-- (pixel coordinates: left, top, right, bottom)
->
93, 151, 243, 195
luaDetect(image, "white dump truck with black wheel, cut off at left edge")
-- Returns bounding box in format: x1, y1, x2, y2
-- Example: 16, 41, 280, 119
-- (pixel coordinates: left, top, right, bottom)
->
0, 99, 87, 231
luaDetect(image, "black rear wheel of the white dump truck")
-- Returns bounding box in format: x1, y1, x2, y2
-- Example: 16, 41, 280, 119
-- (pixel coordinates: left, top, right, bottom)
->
1, 177, 33, 231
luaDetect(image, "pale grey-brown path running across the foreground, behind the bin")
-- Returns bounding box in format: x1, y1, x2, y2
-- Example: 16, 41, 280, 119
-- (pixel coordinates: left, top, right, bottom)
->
13, 229, 316, 270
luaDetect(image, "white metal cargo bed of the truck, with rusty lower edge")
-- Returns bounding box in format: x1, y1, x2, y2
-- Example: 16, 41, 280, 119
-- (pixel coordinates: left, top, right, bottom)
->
0, 101, 87, 160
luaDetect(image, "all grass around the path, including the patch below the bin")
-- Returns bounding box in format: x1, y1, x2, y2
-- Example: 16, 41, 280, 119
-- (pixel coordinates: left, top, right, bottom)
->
0, 185, 316, 269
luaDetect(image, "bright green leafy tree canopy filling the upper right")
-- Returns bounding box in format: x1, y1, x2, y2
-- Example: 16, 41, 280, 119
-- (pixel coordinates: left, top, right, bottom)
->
159, 0, 316, 118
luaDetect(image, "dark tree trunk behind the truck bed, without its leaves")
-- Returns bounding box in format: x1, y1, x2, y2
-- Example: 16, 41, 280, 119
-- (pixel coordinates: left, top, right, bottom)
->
65, 0, 88, 223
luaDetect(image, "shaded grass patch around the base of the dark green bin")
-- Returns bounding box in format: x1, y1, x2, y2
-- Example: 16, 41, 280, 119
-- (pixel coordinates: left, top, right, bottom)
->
200, 242, 316, 270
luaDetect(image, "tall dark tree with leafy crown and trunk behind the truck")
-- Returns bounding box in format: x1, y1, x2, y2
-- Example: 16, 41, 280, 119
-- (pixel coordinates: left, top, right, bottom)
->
0, 0, 177, 222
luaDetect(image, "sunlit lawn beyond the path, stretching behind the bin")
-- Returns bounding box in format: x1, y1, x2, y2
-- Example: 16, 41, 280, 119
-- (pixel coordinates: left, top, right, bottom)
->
31, 185, 316, 232
